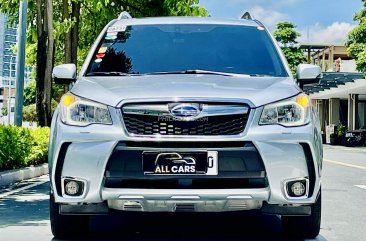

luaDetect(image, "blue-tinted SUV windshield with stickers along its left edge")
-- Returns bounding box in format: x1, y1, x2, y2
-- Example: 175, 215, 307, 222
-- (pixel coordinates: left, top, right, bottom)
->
86, 24, 288, 76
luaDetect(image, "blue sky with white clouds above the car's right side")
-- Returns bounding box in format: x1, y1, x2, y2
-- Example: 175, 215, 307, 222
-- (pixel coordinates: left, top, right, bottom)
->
200, 0, 363, 43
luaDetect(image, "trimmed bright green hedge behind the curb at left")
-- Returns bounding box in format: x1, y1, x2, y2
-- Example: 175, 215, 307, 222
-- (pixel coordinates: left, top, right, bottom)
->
0, 125, 50, 171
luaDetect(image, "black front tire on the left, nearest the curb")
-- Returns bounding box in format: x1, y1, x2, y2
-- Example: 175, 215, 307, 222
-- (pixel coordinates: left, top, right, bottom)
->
50, 195, 89, 239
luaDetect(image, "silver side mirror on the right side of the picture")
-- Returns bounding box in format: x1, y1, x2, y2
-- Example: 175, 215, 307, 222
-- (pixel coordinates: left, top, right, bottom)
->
296, 64, 322, 89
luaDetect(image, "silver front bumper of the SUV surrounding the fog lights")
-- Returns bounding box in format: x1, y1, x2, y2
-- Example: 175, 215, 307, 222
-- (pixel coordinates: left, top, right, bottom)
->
49, 108, 322, 211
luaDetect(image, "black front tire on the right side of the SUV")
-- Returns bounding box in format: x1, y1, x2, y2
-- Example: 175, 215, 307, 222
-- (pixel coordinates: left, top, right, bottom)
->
281, 190, 321, 239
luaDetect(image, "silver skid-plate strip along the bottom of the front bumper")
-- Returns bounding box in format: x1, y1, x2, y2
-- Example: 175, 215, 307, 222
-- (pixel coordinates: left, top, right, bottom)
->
102, 188, 269, 212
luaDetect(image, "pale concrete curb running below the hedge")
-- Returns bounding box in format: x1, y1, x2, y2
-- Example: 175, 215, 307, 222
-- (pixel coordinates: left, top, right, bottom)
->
0, 164, 48, 188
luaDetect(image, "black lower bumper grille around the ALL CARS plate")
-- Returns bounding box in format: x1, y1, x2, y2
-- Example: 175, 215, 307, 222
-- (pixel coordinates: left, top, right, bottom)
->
105, 142, 268, 189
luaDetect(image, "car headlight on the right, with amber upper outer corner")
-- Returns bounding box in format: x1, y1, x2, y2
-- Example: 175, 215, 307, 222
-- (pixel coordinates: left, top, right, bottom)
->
259, 94, 310, 126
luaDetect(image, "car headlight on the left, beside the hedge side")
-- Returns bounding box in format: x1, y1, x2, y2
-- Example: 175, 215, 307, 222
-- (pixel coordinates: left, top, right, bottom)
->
61, 94, 112, 126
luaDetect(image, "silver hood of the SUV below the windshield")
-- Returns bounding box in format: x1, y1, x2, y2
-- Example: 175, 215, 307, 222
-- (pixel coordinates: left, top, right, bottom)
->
71, 74, 301, 107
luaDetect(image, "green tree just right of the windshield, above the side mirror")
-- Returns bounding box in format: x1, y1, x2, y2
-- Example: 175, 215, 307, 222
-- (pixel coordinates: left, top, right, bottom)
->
273, 22, 306, 75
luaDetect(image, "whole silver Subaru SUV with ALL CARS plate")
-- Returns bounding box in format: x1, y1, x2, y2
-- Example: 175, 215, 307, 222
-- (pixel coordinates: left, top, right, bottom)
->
49, 14, 322, 238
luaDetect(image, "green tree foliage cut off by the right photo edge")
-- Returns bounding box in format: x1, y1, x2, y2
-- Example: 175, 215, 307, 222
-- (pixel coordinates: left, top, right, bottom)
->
346, 0, 366, 72
